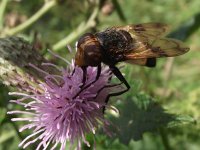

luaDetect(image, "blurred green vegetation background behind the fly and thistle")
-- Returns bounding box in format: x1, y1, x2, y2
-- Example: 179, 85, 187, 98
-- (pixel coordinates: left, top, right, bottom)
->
0, 0, 200, 150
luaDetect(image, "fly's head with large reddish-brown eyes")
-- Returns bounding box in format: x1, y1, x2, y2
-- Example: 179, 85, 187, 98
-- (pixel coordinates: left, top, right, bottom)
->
75, 33, 102, 67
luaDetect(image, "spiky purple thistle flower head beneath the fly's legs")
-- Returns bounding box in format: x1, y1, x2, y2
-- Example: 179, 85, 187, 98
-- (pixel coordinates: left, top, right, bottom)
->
8, 49, 121, 150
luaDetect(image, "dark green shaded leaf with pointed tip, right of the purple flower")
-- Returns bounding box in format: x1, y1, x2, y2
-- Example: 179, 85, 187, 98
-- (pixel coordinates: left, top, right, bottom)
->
112, 93, 194, 144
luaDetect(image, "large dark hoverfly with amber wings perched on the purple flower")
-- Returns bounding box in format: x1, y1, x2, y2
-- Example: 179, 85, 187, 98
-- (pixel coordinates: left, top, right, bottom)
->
75, 23, 189, 101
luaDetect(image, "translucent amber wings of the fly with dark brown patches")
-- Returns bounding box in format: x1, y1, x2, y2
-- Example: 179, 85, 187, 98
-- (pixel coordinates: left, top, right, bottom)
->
112, 23, 189, 61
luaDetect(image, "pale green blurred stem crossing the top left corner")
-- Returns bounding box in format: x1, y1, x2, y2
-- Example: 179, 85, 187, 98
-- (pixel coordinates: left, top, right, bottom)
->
5, 0, 56, 35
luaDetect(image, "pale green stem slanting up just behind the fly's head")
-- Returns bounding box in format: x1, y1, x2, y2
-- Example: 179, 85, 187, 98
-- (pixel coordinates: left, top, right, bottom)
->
52, 6, 99, 51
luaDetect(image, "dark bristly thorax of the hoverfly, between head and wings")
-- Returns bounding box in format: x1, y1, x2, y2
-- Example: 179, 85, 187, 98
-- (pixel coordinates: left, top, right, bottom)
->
95, 28, 133, 65
